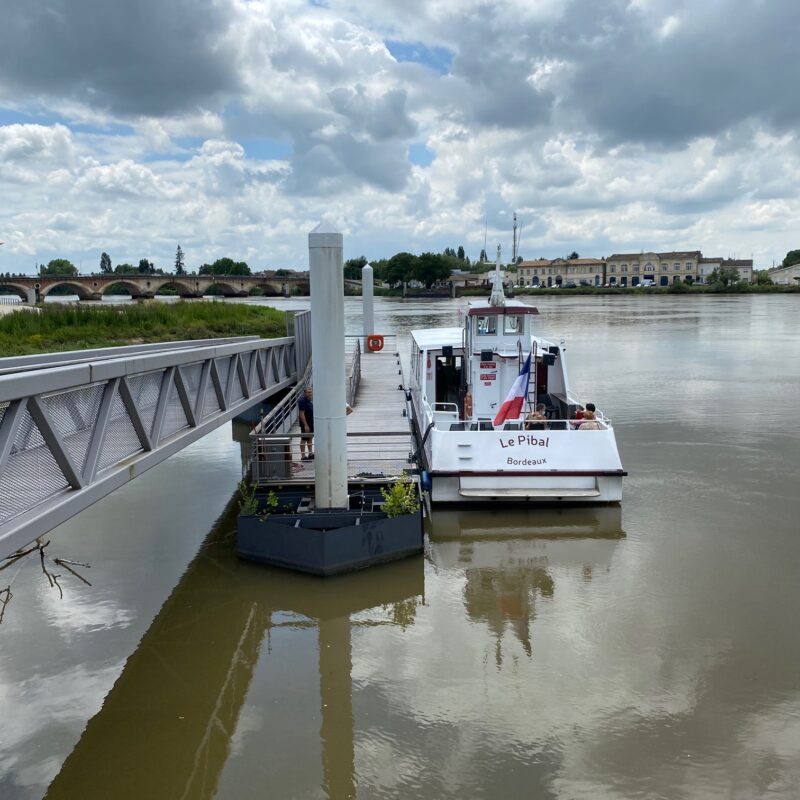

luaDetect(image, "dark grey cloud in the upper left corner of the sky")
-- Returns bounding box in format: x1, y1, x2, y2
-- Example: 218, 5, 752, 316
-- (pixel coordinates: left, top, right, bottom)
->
0, 0, 238, 116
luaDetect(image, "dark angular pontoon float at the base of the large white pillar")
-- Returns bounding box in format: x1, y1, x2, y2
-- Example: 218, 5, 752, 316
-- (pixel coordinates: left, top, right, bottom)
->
237, 508, 423, 575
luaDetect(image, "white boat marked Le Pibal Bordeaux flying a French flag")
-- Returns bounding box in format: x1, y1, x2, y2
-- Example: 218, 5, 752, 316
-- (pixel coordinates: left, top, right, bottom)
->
409, 246, 626, 504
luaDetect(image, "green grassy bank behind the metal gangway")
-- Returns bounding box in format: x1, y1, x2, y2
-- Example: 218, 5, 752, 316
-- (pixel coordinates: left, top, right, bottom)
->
0, 302, 286, 357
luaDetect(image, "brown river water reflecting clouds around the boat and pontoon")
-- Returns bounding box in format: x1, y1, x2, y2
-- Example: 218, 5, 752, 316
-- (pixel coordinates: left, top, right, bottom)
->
0, 295, 800, 800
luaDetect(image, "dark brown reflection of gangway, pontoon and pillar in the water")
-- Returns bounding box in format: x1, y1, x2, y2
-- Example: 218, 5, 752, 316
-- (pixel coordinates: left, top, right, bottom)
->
46, 496, 423, 800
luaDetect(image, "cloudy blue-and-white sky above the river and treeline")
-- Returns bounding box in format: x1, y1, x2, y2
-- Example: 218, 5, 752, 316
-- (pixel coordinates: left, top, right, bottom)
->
0, 0, 800, 272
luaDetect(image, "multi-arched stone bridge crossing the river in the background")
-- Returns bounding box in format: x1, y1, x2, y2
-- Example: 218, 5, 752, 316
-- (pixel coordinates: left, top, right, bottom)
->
0, 273, 324, 303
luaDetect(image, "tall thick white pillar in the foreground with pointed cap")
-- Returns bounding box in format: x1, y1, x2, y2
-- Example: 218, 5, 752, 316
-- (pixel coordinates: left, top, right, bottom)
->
308, 222, 347, 508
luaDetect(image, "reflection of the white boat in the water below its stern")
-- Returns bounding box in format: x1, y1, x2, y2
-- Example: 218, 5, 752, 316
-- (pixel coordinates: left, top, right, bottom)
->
429, 505, 625, 666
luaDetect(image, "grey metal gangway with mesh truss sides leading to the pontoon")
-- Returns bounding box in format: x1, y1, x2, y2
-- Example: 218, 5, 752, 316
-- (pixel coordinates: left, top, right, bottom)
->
0, 312, 311, 559
